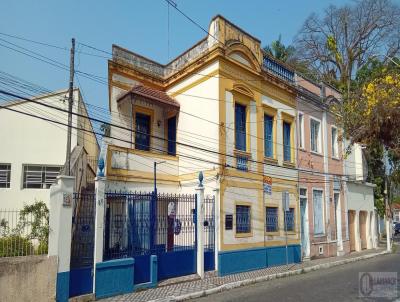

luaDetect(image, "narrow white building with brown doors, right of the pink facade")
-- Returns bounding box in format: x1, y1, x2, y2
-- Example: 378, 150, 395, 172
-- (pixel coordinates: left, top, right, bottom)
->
345, 144, 378, 251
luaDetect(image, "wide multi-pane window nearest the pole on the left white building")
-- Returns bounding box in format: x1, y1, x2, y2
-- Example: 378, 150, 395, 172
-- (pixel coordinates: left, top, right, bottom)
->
23, 165, 61, 189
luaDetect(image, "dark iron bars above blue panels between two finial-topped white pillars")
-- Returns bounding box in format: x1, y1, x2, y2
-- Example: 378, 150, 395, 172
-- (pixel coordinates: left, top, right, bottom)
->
104, 192, 196, 260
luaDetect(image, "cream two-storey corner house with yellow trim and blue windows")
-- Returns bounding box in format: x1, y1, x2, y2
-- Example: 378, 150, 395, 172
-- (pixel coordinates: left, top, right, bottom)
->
101, 16, 300, 274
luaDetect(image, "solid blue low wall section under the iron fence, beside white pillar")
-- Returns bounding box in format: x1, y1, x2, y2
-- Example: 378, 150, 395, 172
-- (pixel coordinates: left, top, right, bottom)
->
95, 258, 135, 299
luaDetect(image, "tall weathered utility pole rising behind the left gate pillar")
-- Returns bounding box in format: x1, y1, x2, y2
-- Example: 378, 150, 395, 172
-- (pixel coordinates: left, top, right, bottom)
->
65, 38, 75, 175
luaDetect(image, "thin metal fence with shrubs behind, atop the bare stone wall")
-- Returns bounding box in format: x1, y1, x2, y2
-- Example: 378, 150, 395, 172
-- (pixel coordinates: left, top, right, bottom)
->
0, 209, 49, 257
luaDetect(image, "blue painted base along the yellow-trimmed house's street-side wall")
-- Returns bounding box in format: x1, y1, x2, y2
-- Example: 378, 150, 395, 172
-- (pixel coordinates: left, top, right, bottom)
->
218, 245, 301, 276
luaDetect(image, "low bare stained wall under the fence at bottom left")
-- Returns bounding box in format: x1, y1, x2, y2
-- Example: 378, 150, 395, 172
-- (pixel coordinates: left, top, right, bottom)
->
0, 255, 57, 302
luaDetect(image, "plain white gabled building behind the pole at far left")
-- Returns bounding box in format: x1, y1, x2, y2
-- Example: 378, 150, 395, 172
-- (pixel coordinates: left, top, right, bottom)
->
0, 89, 99, 209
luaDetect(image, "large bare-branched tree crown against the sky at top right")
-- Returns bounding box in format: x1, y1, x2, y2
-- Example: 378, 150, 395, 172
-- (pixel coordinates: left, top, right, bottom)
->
294, 0, 400, 94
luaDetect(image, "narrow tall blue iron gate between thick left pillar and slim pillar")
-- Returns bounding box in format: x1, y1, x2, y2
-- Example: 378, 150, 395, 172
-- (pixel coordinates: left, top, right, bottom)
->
69, 193, 96, 297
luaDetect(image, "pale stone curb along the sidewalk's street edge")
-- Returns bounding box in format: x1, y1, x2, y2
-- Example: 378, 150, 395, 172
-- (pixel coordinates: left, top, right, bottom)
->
148, 251, 390, 302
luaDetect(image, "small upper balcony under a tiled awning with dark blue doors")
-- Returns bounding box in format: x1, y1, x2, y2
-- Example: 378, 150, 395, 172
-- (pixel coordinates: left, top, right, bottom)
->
107, 85, 180, 178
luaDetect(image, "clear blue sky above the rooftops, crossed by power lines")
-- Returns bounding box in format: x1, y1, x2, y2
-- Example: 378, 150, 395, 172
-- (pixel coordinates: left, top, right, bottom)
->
0, 0, 349, 108
